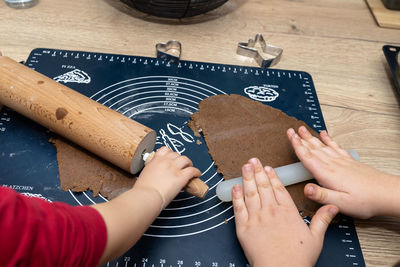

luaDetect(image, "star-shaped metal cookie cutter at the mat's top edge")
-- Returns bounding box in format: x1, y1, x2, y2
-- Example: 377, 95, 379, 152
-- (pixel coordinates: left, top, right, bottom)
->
236, 33, 283, 68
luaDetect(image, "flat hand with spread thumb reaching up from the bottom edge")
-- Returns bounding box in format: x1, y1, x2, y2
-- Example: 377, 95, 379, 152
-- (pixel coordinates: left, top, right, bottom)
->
232, 159, 338, 267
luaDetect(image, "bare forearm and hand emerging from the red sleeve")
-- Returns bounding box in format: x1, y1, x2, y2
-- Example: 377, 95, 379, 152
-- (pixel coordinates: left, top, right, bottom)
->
92, 147, 201, 264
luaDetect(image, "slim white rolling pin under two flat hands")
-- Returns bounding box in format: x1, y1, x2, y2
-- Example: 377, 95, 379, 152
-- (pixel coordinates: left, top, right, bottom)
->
216, 150, 360, 202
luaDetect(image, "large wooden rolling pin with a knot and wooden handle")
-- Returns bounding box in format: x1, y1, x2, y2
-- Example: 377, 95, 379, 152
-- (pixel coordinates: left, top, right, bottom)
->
0, 53, 208, 197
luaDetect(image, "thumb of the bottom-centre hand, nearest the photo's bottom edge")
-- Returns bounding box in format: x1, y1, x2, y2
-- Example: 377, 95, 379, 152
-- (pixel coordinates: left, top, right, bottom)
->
310, 205, 339, 241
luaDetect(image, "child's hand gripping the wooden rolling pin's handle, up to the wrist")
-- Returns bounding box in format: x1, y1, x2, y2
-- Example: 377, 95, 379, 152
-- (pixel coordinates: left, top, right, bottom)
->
135, 147, 201, 207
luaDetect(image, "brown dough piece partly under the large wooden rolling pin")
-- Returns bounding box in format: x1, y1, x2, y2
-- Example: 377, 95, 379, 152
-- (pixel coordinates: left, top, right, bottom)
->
50, 138, 136, 199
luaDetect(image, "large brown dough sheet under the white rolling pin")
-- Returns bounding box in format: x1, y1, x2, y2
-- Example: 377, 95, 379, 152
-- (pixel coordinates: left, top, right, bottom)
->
189, 94, 320, 215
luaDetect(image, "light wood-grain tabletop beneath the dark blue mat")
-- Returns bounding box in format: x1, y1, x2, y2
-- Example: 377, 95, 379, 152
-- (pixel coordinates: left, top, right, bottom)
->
0, 0, 400, 266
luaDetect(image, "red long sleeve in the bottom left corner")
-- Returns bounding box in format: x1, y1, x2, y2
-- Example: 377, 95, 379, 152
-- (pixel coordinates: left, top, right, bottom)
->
0, 187, 107, 266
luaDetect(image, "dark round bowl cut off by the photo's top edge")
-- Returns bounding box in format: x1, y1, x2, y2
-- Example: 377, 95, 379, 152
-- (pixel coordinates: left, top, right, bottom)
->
121, 0, 228, 18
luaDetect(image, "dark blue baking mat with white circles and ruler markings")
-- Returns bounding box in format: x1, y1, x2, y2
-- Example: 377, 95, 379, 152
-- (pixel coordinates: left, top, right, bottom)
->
0, 49, 365, 267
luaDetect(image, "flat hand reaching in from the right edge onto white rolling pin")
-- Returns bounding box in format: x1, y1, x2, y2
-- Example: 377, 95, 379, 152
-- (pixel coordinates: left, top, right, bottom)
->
287, 127, 400, 218
